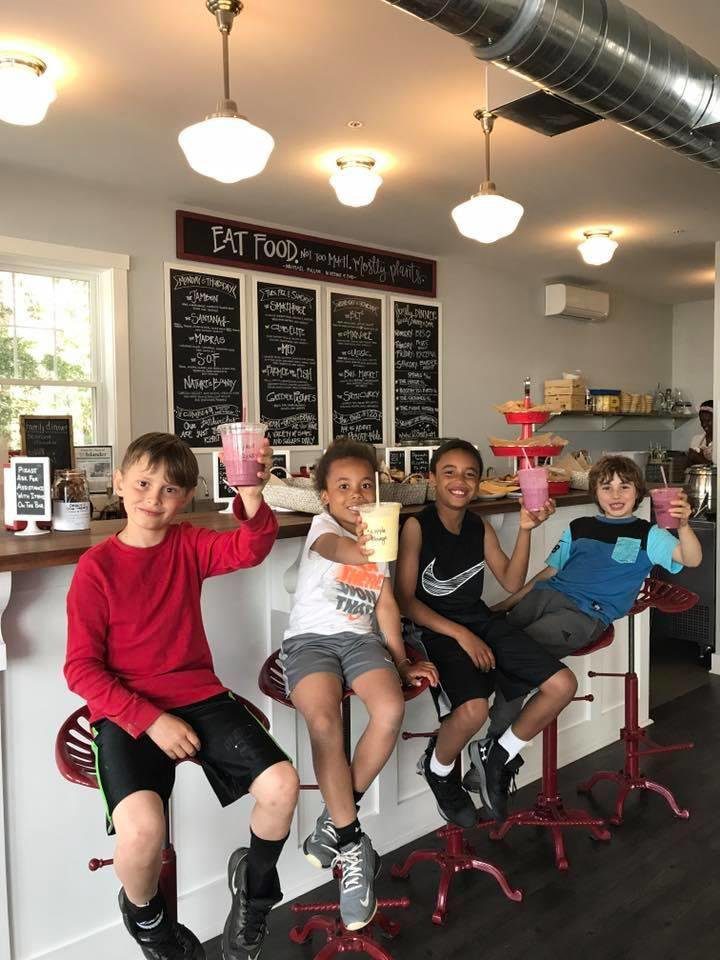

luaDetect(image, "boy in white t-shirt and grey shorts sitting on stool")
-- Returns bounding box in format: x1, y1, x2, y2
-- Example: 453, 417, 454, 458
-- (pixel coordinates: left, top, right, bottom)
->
281, 439, 437, 930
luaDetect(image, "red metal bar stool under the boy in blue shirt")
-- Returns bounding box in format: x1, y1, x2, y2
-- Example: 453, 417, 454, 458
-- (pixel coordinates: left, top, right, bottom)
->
490, 626, 615, 870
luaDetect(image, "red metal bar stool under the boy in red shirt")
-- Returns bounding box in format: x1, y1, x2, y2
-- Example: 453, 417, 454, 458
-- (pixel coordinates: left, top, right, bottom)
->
55, 695, 270, 921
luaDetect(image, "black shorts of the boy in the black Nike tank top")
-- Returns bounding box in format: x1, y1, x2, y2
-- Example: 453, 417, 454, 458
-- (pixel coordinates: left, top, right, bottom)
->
422, 616, 563, 710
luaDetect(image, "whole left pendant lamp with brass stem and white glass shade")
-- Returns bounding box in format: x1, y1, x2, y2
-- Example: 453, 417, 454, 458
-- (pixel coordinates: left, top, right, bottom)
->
178, 0, 275, 183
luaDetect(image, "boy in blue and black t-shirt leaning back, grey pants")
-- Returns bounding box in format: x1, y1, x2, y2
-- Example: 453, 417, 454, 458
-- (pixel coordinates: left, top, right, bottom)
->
463, 456, 702, 792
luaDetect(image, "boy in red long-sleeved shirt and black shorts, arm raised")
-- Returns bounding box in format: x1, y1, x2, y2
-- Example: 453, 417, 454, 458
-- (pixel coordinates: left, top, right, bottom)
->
65, 433, 298, 960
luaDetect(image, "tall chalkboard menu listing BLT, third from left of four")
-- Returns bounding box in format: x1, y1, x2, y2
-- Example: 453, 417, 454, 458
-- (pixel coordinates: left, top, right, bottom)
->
329, 292, 385, 443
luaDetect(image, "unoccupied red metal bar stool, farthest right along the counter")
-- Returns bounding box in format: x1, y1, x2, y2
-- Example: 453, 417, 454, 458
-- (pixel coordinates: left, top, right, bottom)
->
577, 577, 698, 827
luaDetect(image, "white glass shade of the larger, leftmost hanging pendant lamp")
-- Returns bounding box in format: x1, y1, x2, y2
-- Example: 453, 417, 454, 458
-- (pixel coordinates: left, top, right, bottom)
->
178, 117, 275, 183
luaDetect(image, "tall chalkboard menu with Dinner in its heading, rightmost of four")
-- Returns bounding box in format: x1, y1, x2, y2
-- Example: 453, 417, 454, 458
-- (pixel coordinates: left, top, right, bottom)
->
392, 299, 441, 443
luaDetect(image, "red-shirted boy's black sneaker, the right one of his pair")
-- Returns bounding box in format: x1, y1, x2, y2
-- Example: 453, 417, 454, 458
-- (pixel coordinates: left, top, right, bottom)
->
221, 847, 282, 960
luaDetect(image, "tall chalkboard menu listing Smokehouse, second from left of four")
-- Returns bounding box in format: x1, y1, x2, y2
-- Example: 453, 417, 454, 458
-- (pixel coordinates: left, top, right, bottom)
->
255, 282, 320, 447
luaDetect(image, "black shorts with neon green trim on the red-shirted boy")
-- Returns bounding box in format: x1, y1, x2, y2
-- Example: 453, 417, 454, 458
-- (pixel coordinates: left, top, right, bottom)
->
93, 693, 289, 834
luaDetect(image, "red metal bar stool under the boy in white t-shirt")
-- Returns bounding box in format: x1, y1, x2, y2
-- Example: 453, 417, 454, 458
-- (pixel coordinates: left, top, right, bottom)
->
258, 647, 428, 960
